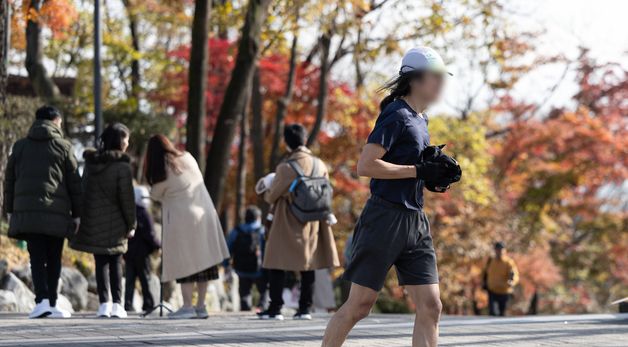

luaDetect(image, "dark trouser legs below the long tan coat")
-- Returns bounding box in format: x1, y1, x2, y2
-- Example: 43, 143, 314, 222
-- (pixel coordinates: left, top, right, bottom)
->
268, 270, 315, 313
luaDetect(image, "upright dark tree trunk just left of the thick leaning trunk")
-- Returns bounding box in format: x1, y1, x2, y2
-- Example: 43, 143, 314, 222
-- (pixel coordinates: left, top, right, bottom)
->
185, 0, 211, 164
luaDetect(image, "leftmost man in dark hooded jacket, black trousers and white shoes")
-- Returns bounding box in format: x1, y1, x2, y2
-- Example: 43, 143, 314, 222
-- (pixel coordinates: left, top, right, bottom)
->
3, 106, 81, 318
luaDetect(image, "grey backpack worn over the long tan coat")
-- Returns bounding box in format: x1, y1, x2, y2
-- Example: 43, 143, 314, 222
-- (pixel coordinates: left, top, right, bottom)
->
288, 157, 334, 223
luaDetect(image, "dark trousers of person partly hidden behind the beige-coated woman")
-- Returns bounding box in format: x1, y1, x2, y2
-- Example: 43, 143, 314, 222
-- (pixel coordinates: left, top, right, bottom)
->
124, 255, 155, 311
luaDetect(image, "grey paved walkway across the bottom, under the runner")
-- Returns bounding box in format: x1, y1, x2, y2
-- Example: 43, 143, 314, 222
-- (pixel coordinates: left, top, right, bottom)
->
0, 314, 628, 347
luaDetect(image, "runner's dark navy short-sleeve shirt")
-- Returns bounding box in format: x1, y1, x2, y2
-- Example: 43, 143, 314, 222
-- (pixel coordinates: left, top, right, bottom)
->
367, 99, 430, 211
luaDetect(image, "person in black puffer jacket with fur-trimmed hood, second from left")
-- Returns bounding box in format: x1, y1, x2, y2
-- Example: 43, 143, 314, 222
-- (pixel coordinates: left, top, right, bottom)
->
70, 123, 136, 318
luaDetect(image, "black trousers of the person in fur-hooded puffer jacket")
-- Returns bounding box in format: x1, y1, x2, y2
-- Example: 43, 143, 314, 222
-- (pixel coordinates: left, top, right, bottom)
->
94, 254, 122, 304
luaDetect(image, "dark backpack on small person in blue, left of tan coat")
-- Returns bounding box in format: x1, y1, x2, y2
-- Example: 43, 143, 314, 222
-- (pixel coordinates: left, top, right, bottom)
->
232, 227, 262, 272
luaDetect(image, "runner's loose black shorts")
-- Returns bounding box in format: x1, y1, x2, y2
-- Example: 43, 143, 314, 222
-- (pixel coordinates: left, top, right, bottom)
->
343, 196, 438, 291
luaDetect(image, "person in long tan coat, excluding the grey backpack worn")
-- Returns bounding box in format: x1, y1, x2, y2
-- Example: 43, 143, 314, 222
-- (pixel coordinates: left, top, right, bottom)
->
259, 124, 340, 320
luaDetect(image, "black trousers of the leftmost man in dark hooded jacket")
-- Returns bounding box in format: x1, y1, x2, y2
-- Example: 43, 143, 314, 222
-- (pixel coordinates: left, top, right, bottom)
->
27, 234, 64, 307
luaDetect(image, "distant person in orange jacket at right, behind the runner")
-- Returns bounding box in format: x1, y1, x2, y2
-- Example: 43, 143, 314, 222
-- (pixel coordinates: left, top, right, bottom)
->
484, 242, 519, 316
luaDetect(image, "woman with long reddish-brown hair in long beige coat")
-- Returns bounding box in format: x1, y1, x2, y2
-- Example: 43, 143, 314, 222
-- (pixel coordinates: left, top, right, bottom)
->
146, 135, 229, 319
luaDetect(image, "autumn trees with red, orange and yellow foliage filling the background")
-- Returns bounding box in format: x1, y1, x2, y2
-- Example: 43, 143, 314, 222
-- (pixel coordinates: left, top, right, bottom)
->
2, 0, 628, 314
